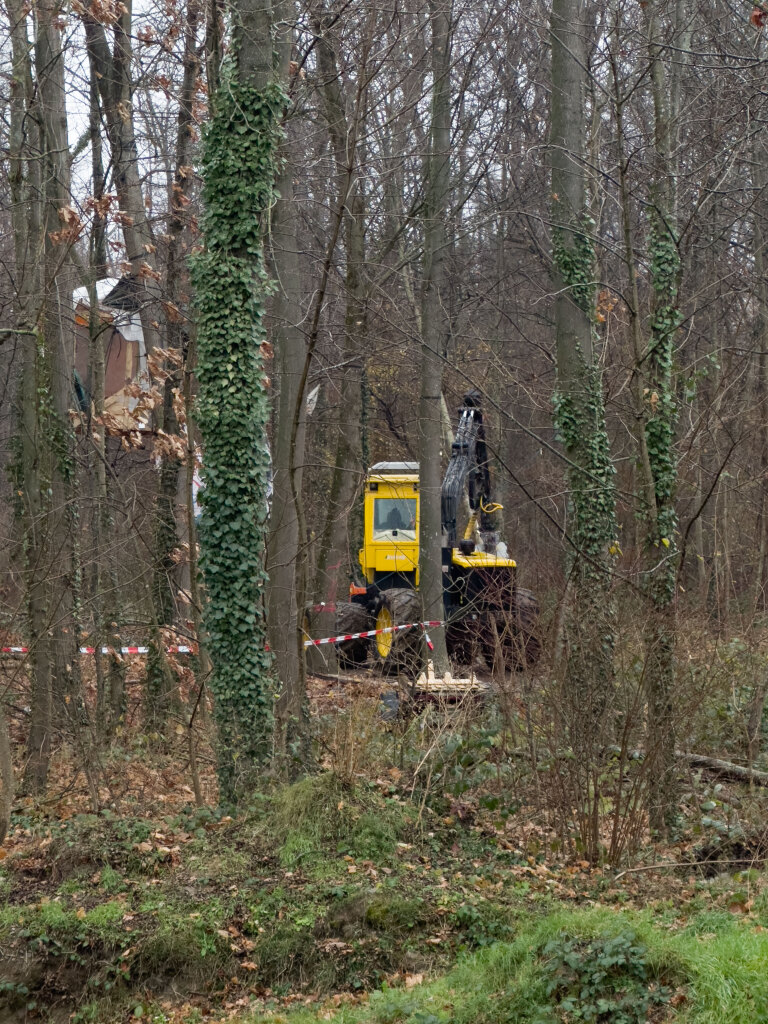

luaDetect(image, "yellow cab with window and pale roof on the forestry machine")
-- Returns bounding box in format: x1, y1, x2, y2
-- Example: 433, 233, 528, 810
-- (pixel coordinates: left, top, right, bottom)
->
359, 462, 419, 589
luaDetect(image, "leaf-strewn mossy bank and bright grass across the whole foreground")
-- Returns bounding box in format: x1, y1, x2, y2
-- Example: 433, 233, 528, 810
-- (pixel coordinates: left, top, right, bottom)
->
0, 772, 768, 1024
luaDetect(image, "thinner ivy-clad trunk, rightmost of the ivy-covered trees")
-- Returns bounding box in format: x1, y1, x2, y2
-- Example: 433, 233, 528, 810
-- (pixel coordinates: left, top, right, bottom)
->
638, 0, 681, 831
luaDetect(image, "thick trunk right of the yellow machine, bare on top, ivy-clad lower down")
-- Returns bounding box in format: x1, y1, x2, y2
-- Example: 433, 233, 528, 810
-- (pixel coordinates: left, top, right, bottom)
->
550, 0, 616, 729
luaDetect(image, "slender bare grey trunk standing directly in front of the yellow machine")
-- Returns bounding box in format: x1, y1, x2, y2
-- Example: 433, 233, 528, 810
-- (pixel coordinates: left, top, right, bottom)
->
419, 0, 452, 675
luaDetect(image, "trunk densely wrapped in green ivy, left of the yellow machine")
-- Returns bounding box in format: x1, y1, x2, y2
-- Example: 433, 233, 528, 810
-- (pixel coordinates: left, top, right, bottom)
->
193, 0, 285, 800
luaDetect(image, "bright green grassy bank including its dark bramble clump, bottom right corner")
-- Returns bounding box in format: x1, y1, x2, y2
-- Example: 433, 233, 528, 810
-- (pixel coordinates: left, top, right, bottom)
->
259, 908, 768, 1024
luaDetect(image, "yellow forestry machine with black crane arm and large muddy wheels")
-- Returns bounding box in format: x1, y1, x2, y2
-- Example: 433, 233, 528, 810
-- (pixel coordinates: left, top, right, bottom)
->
336, 391, 541, 675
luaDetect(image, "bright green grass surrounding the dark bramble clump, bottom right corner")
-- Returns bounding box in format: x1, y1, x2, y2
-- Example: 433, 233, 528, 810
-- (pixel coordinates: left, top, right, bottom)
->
249, 908, 768, 1024
